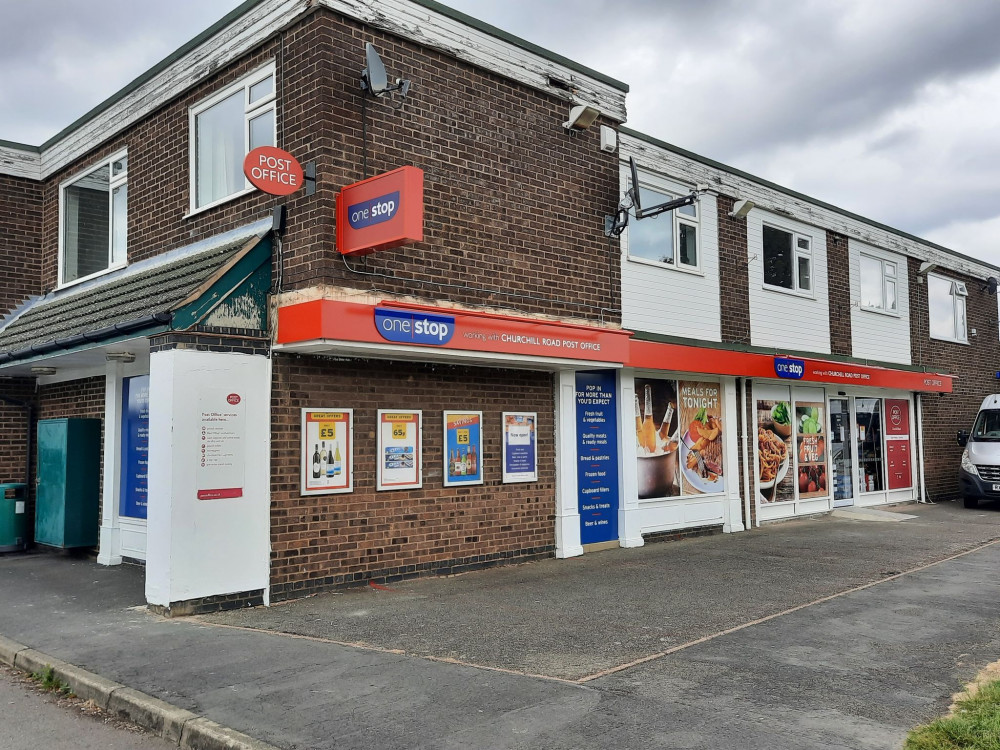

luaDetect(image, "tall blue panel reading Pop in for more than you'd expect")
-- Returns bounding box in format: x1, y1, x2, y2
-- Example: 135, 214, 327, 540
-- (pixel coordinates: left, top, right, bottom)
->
576, 370, 618, 544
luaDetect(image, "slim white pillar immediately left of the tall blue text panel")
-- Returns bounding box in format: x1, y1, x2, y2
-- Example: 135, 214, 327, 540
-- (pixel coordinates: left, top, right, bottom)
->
555, 370, 583, 557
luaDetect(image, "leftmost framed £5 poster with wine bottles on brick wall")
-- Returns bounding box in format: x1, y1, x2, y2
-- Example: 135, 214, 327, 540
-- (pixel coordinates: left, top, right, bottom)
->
301, 409, 354, 495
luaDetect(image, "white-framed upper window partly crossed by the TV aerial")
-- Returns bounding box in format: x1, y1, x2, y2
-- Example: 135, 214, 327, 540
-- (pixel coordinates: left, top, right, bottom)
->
627, 175, 701, 271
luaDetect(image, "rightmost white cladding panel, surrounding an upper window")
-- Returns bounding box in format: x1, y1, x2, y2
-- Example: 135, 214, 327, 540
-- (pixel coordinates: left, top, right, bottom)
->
848, 240, 911, 365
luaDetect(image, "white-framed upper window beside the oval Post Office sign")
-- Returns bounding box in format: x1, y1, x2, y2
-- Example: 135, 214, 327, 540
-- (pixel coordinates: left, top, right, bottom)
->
189, 62, 277, 213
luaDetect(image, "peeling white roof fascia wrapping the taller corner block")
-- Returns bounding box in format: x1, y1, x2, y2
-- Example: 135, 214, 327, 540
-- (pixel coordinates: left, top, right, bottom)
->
0, 0, 625, 180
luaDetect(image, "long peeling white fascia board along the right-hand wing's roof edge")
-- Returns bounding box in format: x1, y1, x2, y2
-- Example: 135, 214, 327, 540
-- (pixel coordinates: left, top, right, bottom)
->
618, 133, 997, 279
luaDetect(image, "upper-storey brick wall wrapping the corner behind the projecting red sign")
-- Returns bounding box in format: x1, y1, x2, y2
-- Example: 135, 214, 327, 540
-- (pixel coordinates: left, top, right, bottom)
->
33, 10, 620, 320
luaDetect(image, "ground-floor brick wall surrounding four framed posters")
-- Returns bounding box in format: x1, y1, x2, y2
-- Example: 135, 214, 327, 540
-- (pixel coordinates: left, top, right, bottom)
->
271, 355, 555, 599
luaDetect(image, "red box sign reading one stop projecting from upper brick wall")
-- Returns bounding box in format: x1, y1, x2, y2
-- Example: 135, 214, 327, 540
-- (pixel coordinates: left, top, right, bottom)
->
337, 167, 424, 255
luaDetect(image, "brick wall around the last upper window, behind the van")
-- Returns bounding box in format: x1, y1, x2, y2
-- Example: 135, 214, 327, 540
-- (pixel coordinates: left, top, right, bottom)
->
908, 258, 1000, 500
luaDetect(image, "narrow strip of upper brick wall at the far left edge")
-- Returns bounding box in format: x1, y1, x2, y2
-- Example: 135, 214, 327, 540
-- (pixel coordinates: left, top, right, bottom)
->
0, 174, 42, 315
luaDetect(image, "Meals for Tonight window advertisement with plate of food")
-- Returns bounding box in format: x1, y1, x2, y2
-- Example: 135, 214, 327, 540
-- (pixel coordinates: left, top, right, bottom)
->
676, 380, 726, 495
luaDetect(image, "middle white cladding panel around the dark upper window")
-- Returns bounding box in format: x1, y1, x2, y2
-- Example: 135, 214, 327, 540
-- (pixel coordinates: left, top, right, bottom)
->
747, 208, 830, 354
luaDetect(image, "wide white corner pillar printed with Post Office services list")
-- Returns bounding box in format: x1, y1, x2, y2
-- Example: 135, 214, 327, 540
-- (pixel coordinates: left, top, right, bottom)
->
146, 349, 270, 606
